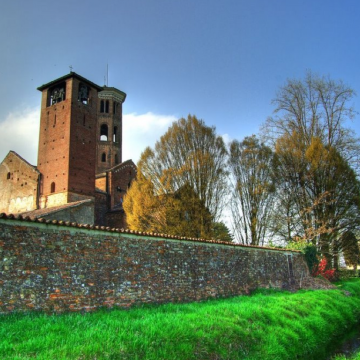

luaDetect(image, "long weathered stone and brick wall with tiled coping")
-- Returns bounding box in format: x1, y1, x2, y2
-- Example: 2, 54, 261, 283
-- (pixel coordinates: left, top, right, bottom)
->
0, 214, 309, 313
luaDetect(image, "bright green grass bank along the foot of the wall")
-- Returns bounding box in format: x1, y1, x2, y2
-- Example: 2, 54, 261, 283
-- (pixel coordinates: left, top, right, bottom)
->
0, 280, 360, 360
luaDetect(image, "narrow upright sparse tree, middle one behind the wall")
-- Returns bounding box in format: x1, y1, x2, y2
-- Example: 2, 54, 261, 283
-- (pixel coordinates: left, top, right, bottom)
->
229, 135, 274, 245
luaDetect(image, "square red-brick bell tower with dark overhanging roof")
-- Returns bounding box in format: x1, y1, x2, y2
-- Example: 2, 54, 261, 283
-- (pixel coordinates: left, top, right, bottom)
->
37, 72, 102, 208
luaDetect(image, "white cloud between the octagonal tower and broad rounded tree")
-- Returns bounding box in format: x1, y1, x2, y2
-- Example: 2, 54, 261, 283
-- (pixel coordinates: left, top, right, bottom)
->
122, 112, 177, 164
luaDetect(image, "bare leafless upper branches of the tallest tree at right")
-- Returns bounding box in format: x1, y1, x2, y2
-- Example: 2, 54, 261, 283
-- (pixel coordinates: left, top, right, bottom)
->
262, 72, 360, 167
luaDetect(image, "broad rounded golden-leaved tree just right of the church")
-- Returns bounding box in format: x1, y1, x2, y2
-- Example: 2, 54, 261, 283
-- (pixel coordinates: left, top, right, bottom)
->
124, 115, 228, 237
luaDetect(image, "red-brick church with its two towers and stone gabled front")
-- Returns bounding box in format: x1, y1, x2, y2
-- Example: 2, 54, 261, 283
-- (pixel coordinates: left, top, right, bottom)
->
0, 72, 136, 227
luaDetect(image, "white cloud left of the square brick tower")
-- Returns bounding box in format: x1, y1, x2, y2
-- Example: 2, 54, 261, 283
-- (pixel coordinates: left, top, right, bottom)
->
0, 107, 40, 165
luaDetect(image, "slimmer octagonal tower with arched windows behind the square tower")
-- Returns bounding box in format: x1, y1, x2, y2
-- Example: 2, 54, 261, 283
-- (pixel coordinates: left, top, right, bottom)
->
96, 86, 126, 174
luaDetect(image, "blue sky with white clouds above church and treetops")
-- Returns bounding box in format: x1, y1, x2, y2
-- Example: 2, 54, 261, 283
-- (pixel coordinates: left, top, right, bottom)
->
0, 0, 360, 164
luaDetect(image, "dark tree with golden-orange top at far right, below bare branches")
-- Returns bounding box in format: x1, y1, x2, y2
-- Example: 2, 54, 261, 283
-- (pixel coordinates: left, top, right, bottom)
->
305, 138, 360, 267
